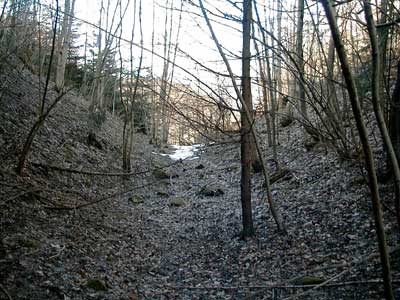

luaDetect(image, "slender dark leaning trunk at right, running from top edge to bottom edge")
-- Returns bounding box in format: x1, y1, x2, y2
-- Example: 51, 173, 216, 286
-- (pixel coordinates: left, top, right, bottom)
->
320, 0, 394, 300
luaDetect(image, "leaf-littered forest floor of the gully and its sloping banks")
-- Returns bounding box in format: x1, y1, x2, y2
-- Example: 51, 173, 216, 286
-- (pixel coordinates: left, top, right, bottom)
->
0, 69, 400, 300
